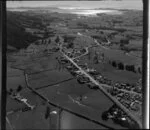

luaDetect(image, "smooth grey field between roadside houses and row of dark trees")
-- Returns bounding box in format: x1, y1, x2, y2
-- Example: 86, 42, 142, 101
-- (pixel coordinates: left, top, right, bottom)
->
79, 56, 141, 83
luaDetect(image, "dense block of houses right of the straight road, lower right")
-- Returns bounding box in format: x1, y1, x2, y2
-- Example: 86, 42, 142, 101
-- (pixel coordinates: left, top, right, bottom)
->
95, 76, 142, 112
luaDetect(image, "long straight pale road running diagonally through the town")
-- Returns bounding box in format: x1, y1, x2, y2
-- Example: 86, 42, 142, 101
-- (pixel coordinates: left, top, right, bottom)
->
60, 44, 142, 128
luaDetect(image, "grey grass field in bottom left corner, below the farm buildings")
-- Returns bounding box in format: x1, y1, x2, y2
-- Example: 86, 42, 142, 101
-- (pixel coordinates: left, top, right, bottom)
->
8, 106, 50, 130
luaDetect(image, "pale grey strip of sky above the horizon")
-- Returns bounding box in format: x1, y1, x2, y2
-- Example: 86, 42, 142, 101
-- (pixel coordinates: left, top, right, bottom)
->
7, 0, 143, 10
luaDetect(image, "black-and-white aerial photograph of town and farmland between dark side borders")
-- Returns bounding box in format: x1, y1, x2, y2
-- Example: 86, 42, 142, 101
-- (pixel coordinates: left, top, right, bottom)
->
6, 0, 143, 130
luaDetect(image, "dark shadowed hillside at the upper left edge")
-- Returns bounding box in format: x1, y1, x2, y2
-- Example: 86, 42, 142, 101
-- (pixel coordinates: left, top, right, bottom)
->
7, 11, 38, 49
